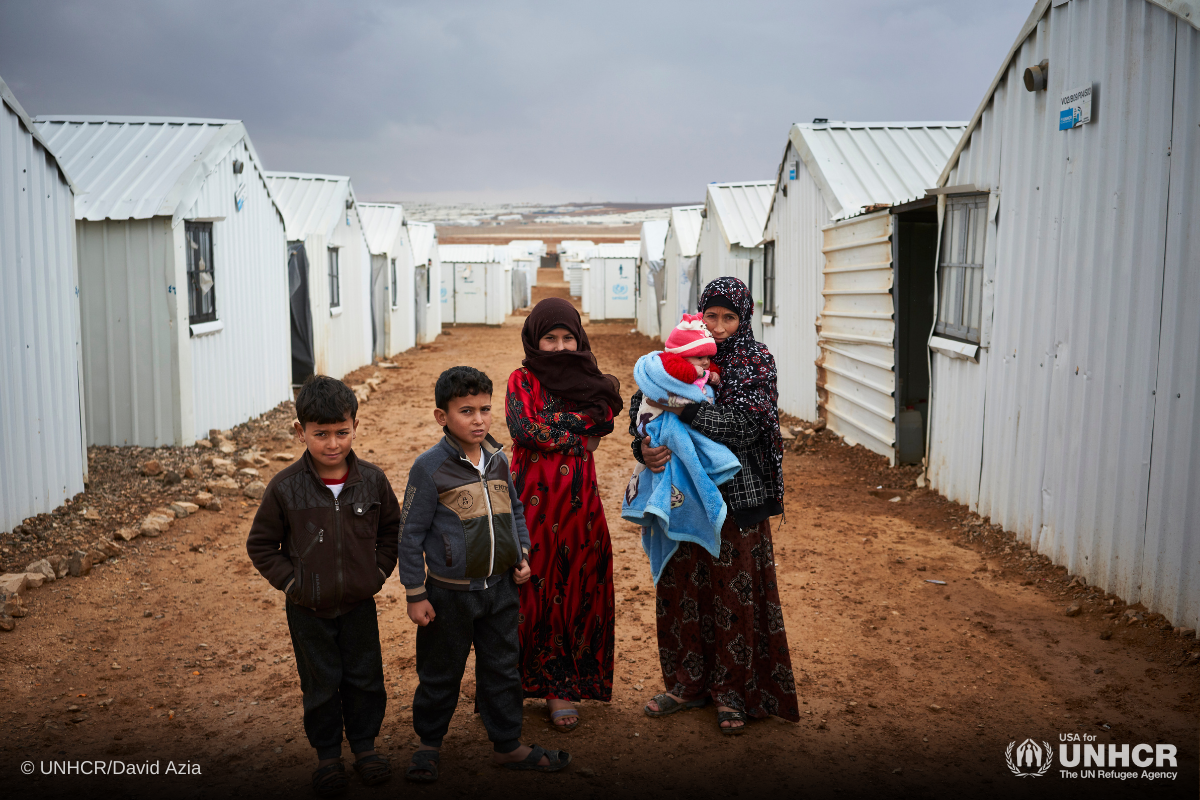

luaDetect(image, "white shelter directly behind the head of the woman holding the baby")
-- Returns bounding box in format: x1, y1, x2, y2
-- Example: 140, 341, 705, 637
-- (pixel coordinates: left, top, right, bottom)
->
697, 181, 775, 341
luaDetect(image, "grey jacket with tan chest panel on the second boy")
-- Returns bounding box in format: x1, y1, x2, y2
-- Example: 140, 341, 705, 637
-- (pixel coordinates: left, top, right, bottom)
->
397, 434, 529, 602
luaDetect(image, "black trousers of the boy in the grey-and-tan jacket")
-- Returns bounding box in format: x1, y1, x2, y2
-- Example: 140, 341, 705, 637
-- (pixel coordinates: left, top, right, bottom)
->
413, 573, 524, 753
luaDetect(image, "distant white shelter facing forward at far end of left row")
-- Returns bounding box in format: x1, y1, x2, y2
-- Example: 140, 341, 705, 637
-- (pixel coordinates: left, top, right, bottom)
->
438, 245, 511, 325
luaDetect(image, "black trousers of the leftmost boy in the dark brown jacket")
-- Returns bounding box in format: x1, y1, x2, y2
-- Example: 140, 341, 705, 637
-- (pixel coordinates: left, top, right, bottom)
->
287, 599, 388, 758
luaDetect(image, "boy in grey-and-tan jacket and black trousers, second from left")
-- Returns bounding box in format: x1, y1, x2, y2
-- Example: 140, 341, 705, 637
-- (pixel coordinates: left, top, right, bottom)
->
398, 367, 571, 783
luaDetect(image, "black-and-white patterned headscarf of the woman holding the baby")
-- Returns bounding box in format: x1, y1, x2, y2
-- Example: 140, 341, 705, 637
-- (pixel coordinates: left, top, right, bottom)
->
698, 277, 784, 500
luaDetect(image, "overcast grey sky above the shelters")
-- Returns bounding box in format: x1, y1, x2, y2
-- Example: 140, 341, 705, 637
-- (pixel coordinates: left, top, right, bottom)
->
0, 0, 1032, 203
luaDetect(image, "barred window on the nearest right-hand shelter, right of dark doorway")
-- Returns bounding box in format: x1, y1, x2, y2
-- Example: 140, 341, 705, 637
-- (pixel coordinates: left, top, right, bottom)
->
936, 194, 988, 344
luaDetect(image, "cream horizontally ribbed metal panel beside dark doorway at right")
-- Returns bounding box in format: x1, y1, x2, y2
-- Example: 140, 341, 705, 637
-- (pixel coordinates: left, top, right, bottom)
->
816, 211, 896, 463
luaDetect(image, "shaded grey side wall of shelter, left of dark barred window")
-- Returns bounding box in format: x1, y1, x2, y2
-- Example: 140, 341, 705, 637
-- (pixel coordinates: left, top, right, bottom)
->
76, 217, 175, 447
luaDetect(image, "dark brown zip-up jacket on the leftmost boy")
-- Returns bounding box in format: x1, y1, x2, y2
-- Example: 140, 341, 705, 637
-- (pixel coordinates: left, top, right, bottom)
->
246, 450, 400, 618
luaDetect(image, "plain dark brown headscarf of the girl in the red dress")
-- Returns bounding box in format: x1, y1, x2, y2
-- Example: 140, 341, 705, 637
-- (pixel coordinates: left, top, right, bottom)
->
521, 297, 625, 422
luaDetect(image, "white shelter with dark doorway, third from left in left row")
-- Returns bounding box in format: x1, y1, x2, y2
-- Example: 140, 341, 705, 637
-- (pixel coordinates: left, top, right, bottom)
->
266, 173, 373, 383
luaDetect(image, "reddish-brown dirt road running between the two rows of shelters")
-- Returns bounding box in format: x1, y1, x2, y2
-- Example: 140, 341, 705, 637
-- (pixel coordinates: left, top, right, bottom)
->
0, 271, 1200, 798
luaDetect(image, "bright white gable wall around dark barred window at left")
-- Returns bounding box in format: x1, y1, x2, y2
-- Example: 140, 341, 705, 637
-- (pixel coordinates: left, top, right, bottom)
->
181, 136, 292, 439
